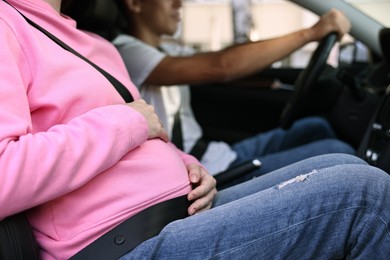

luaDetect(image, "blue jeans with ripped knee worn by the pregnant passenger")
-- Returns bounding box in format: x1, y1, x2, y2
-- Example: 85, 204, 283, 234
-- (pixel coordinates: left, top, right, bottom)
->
122, 154, 390, 260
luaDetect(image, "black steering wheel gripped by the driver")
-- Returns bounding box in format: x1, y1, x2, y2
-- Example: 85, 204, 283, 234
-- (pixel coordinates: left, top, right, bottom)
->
280, 33, 337, 128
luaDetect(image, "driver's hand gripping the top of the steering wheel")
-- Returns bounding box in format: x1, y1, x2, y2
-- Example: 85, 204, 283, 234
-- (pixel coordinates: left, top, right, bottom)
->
310, 9, 351, 41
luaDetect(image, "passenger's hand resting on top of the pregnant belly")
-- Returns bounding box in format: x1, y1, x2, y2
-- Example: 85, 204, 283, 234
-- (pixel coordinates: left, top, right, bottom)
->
127, 99, 169, 142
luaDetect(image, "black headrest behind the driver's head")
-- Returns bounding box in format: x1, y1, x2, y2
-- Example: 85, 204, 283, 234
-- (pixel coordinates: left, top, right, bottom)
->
62, 0, 125, 40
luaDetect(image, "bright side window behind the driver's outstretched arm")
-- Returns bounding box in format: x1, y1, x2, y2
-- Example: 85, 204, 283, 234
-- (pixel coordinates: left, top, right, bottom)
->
179, 0, 318, 67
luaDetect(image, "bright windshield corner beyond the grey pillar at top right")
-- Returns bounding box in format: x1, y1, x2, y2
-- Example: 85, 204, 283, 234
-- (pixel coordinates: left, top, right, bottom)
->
345, 0, 390, 27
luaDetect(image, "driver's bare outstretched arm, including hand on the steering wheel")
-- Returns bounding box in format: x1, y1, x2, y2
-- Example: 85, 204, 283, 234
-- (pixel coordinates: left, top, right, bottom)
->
144, 10, 350, 85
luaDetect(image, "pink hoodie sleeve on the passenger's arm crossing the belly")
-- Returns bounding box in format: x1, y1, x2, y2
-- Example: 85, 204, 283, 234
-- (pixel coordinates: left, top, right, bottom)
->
0, 19, 148, 219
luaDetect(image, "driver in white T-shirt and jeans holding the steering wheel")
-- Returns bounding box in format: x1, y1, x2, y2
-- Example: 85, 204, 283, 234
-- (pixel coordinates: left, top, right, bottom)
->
113, 0, 354, 186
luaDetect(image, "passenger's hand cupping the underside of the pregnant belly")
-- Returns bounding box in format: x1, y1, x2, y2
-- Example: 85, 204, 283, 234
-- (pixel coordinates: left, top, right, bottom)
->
187, 164, 217, 215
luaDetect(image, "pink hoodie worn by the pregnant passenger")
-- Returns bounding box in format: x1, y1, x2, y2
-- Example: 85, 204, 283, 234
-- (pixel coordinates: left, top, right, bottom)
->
0, 0, 198, 259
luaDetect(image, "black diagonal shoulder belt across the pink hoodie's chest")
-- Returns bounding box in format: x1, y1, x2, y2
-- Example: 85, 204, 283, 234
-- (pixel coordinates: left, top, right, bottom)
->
3, 0, 134, 103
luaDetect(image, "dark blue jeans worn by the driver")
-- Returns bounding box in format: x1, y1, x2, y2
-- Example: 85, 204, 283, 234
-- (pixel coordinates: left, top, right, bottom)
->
225, 117, 355, 189
